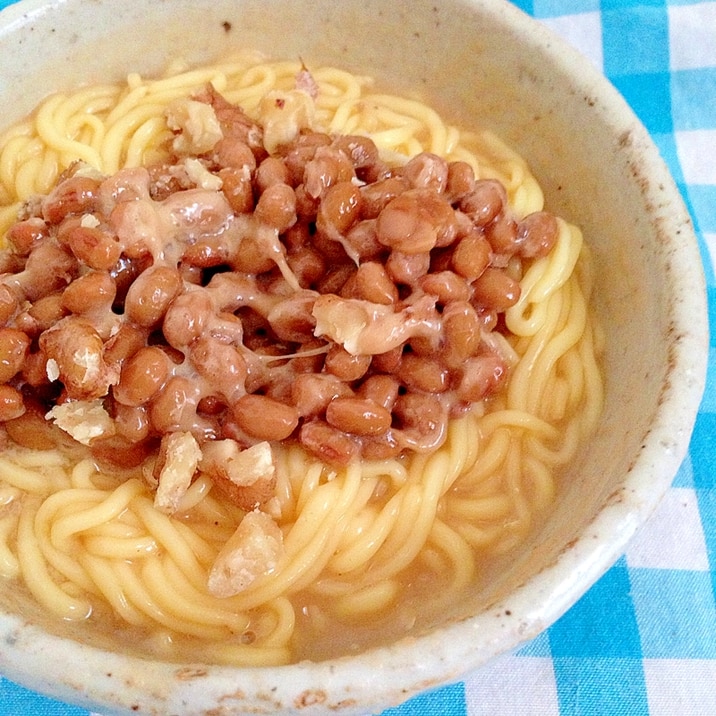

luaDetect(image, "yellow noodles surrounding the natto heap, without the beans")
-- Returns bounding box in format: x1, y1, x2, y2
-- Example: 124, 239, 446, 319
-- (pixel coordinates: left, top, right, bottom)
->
0, 57, 602, 665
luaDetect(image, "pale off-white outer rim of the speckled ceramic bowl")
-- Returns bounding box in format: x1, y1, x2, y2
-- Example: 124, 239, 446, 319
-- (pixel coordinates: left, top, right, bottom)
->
0, 0, 709, 714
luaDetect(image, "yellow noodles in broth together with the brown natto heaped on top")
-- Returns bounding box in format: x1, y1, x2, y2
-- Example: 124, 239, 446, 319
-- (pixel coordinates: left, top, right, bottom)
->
0, 55, 602, 665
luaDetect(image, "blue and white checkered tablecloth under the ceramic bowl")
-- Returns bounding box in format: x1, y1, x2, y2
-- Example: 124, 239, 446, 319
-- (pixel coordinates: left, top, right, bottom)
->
0, 0, 716, 716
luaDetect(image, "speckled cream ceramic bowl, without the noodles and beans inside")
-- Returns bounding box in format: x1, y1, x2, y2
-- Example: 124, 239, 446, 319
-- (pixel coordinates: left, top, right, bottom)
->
0, 0, 708, 716
